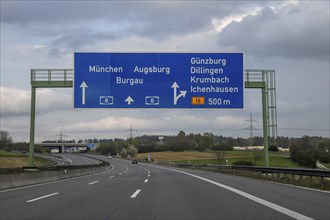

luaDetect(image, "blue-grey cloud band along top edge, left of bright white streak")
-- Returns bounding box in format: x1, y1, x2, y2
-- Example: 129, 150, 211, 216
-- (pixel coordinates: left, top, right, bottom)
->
1, 1, 279, 39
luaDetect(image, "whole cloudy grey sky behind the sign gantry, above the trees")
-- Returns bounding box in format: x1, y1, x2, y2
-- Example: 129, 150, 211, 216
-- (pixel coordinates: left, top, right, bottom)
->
0, 0, 330, 142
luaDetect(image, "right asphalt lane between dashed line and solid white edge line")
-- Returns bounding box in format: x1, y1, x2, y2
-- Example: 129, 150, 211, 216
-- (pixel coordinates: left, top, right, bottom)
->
110, 163, 290, 219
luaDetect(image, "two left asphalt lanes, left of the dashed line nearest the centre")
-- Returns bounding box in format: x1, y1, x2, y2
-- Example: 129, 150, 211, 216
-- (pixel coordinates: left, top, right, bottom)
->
0, 157, 147, 219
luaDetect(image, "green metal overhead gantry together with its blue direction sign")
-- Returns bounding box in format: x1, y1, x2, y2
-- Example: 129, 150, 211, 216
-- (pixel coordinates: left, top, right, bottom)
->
29, 53, 277, 166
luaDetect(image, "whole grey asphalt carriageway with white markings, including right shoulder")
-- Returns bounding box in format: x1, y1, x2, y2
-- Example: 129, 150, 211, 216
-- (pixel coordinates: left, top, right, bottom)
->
0, 157, 330, 220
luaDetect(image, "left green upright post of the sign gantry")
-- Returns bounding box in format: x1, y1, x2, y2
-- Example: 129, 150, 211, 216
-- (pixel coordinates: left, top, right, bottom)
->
29, 86, 36, 167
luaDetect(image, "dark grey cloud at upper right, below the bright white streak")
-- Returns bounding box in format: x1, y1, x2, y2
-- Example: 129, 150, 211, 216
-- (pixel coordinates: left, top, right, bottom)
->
218, 2, 329, 60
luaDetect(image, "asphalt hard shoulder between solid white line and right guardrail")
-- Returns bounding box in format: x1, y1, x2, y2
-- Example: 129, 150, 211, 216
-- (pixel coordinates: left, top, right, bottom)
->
187, 168, 330, 219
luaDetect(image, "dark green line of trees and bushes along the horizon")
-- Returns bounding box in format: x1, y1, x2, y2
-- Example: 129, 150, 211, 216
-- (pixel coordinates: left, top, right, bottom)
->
0, 130, 330, 167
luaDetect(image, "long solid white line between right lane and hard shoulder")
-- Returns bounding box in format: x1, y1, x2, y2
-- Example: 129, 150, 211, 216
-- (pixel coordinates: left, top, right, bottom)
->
148, 166, 313, 220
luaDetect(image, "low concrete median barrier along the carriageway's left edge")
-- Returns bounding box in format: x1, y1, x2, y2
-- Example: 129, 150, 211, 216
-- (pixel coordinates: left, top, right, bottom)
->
0, 165, 111, 190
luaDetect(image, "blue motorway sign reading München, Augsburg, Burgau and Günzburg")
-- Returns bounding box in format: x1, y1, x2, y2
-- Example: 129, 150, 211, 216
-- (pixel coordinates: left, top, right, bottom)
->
74, 53, 244, 108
